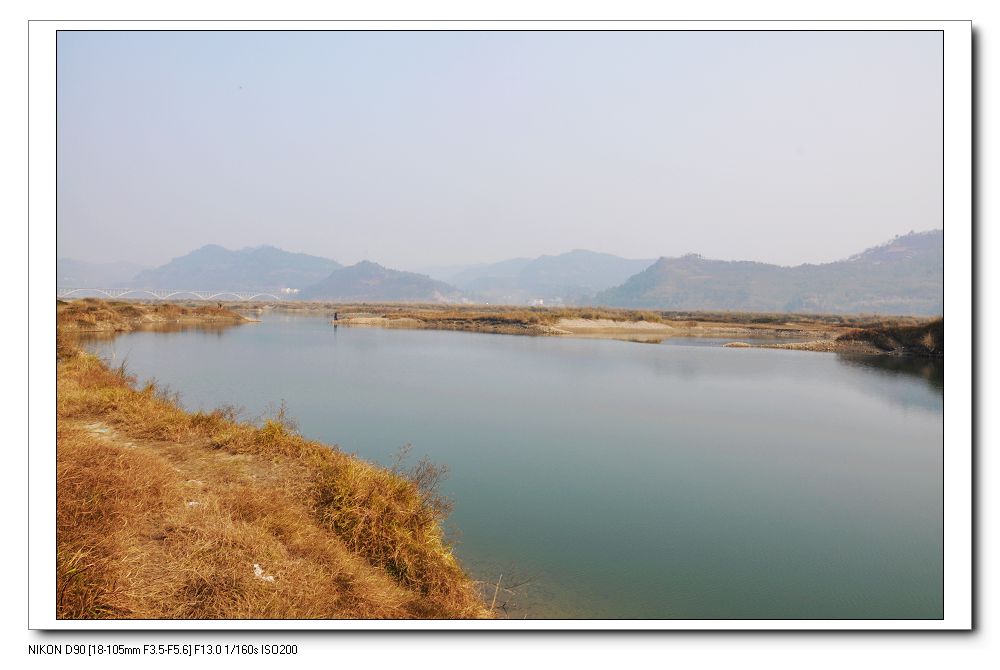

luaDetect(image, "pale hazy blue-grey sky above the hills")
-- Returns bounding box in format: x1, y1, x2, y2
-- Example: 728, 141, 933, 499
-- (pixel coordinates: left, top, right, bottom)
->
58, 31, 942, 269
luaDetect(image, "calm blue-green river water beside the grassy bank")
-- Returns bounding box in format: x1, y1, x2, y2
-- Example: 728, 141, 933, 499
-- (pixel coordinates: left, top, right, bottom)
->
82, 315, 943, 619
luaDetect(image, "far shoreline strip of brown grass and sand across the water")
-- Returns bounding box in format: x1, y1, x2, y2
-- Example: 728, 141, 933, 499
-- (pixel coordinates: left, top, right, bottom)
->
57, 298, 944, 357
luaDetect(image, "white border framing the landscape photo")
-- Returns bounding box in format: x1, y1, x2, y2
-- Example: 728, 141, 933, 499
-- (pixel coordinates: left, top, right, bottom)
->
25, 20, 975, 631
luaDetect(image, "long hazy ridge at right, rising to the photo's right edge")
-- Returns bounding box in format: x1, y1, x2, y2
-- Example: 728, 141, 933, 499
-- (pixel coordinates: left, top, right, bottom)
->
593, 230, 944, 314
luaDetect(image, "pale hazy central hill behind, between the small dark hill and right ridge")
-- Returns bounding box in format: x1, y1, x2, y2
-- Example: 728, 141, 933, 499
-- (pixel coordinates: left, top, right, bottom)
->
451, 249, 653, 304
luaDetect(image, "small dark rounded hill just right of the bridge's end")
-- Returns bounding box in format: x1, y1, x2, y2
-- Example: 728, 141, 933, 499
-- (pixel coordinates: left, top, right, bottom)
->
296, 261, 462, 302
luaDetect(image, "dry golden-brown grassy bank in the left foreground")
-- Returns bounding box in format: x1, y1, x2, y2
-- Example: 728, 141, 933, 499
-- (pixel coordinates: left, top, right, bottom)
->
57, 336, 489, 619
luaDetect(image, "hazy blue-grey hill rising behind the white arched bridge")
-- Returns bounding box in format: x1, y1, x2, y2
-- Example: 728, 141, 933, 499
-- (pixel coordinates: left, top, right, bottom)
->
131, 244, 342, 291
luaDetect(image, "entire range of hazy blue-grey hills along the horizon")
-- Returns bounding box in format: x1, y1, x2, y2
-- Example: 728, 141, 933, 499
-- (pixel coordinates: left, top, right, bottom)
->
58, 230, 944, 314
